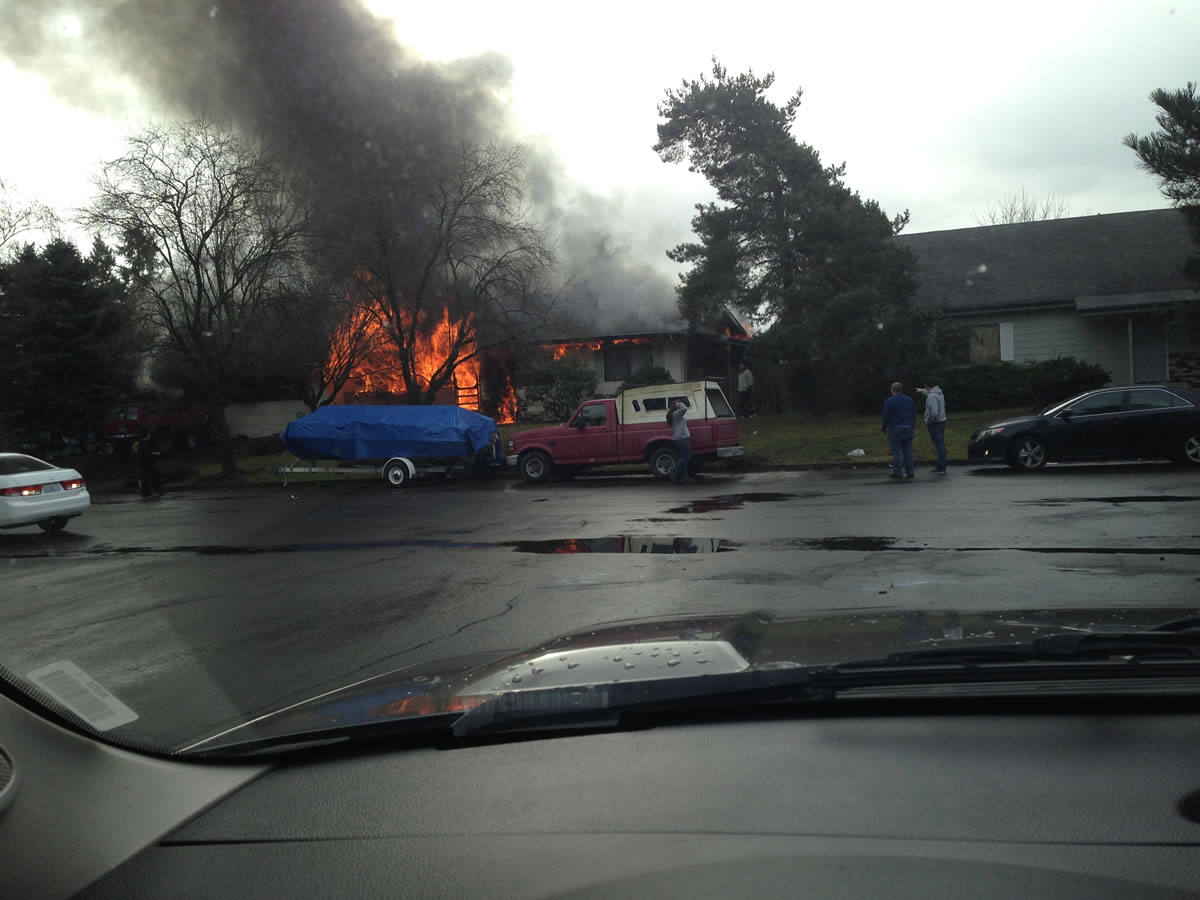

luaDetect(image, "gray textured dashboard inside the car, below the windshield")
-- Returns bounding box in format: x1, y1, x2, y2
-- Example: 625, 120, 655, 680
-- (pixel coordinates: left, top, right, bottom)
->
0, 697, 1200, 899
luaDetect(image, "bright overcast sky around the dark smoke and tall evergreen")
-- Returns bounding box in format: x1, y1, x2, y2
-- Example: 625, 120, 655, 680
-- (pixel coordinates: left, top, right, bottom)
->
0, 0, 1200, 265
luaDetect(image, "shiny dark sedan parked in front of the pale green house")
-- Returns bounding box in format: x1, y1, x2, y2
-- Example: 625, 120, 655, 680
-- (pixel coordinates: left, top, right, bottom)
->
967, 385, 1200, 470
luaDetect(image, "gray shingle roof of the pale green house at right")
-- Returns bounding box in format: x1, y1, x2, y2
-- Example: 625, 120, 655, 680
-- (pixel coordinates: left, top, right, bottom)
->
896, 209, 1198, 313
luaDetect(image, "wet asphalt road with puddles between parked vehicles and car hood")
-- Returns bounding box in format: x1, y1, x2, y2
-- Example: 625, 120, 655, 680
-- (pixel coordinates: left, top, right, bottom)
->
0, 464, 1200, 742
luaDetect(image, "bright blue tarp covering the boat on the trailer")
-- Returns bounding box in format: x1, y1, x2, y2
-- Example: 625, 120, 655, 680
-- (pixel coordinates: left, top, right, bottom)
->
280, 406, 496, 460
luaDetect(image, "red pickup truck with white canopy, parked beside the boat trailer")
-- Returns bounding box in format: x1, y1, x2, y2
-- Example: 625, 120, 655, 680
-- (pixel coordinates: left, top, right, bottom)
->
506, 382, 745, 482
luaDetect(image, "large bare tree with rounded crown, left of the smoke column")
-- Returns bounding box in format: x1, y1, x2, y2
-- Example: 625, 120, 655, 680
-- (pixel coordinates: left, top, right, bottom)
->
84, 119, 307, 473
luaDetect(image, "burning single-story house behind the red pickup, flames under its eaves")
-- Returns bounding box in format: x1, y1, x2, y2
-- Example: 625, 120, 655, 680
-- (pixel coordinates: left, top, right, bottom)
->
535, 311, 750, 395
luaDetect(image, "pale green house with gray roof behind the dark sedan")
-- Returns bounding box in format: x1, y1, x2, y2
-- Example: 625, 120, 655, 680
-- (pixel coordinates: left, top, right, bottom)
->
896, 209, 1200, 386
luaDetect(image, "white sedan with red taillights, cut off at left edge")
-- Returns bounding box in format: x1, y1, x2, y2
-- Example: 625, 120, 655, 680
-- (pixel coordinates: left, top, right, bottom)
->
0, 454, 91, 532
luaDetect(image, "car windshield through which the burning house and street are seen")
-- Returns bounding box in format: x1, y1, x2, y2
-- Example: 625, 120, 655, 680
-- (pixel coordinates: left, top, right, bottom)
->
0, 0, 1200, 754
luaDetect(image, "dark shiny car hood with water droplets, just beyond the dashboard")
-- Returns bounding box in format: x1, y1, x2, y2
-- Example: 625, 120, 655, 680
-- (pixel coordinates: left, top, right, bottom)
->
187, 607, 1196, 752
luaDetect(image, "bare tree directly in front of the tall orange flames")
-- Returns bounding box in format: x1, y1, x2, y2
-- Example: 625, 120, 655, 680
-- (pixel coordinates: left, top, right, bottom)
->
333, 145, 554, 403
